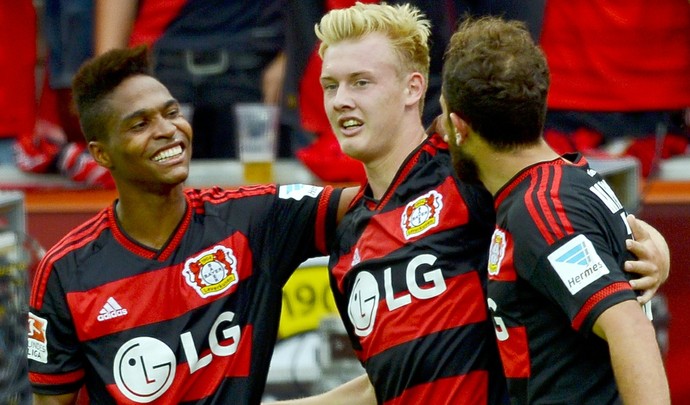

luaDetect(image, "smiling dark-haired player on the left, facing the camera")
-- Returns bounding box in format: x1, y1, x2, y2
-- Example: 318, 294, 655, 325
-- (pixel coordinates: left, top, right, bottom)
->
28, 47, 354, 404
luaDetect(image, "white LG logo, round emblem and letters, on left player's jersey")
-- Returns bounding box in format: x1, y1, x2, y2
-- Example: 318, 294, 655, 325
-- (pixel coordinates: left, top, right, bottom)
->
113, 311, 240, 403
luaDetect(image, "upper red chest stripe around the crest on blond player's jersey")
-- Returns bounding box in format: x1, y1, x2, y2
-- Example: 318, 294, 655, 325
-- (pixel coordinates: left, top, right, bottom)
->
332, 177, 469, 291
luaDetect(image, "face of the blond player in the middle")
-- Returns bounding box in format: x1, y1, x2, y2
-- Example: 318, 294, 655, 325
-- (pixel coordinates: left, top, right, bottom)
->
320, 33, 406, 164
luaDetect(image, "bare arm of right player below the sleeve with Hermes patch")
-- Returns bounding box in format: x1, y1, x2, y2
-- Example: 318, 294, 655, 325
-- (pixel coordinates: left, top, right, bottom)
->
593, 300, 671, 405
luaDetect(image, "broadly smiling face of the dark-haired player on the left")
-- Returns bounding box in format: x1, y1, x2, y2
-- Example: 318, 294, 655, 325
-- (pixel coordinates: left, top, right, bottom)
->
95, 75, 192, 188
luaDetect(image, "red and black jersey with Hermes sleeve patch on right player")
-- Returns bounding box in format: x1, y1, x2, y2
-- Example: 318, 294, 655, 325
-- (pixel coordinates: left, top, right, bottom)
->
488, 155, 635, 404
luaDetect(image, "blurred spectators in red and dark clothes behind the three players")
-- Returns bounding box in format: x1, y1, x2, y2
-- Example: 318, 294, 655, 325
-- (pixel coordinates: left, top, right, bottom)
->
0, 0, 690, 188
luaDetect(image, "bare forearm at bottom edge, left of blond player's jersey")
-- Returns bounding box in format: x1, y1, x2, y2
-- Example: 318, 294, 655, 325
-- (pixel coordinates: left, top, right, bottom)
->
263, 374, 376, 405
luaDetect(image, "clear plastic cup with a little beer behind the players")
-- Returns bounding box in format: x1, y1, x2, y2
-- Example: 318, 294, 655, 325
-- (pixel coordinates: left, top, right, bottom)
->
234, 103, 279, 184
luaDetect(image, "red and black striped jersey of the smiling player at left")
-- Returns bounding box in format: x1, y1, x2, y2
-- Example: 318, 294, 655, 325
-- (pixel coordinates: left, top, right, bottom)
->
29, 185, 340, 404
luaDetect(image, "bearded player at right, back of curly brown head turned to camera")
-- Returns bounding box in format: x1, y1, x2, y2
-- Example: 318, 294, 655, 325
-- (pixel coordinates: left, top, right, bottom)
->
441, 17, 670, 404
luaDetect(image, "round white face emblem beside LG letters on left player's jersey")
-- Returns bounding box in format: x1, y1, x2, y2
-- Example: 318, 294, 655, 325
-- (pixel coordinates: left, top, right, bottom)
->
113, 337, 177, 403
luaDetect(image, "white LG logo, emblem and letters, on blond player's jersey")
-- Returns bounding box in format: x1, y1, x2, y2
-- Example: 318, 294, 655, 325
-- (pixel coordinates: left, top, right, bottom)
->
347, 254, 447, 337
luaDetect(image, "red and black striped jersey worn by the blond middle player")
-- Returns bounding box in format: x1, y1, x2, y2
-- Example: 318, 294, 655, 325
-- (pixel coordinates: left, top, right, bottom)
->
329, 135, 505, 404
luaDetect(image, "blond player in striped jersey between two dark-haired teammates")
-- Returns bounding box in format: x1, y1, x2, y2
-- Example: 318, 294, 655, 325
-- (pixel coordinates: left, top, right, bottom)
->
272, 3, 668, 404
